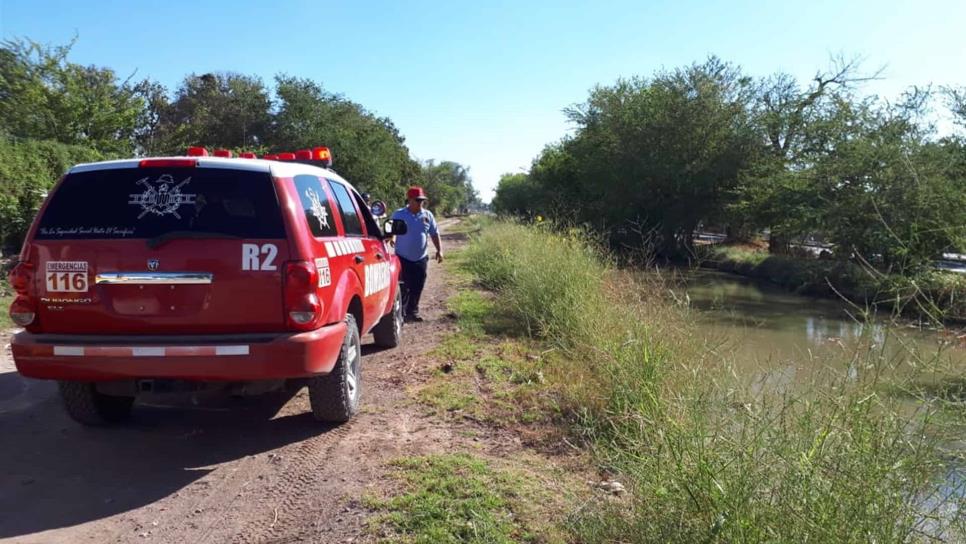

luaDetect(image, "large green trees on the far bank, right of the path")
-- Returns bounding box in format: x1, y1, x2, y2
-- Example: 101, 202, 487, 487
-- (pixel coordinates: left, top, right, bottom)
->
493, 57, 966, 317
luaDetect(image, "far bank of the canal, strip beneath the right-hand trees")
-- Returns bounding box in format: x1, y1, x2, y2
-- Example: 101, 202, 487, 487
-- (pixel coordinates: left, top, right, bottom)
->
700, 246, 966, 323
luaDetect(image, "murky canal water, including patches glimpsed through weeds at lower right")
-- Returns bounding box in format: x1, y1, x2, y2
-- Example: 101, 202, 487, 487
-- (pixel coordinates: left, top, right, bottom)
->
672, 269, 966, 541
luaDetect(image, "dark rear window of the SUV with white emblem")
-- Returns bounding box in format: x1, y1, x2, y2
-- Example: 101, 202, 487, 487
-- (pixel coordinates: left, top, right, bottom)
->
36, 168, 285, 240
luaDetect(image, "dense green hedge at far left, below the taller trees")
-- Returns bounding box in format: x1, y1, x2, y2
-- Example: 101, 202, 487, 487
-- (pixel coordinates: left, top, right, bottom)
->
0, 135, 103, 247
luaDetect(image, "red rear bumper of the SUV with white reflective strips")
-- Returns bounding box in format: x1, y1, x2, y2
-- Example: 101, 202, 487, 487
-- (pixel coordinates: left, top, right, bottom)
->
11, 322, 346, 381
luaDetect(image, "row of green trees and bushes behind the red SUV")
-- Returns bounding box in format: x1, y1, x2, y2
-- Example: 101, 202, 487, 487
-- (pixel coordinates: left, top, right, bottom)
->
0, 39, 479, 250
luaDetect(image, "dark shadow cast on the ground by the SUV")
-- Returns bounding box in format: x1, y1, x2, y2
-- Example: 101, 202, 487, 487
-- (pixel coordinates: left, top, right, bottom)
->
0, 372, 332, 539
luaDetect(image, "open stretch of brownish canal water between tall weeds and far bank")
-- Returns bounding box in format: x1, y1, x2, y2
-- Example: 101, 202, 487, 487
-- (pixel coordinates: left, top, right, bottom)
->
676, 270, 966, 389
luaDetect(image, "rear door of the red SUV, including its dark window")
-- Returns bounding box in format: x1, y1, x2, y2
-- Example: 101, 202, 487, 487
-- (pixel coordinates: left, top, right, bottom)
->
29, 160, 290, 334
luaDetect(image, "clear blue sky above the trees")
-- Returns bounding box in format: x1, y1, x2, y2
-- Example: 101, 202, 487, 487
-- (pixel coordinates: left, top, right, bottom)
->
0, 0, 966, 200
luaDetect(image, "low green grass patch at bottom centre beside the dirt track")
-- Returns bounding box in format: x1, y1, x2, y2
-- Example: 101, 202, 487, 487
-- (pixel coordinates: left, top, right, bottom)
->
367, 453, 572, 544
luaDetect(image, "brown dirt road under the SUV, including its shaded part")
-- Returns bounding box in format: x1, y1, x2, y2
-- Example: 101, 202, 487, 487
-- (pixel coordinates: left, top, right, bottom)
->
0, 222, 474, 543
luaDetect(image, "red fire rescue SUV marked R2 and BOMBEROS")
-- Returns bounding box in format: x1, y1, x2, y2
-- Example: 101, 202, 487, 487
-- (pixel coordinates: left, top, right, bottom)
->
4, 148, 405, 425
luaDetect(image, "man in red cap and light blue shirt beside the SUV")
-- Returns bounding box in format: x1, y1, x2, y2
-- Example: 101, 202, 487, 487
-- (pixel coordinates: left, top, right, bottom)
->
392, 187, 443, 322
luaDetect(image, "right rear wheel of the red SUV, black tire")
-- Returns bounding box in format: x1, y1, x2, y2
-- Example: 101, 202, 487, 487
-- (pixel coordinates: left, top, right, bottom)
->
308, 314, 362, 423
